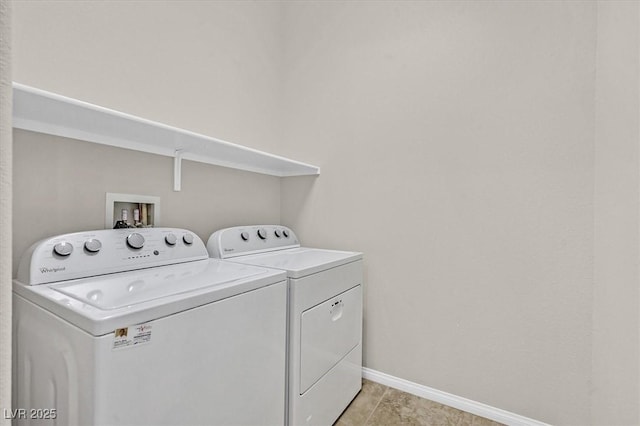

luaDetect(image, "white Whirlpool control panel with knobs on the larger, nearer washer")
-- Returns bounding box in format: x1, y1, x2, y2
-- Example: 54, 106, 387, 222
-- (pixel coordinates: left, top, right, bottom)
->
18, 228, 209, 285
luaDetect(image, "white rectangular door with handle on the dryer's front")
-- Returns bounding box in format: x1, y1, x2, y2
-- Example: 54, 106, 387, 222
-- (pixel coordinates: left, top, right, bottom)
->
300, 285, 362, 395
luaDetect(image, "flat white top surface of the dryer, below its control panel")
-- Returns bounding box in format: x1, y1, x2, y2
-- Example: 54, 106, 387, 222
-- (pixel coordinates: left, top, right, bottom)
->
230, 247, 362, 278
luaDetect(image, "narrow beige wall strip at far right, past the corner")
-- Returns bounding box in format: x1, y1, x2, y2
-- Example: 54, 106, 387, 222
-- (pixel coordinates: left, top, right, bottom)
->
592, 2, 640, 425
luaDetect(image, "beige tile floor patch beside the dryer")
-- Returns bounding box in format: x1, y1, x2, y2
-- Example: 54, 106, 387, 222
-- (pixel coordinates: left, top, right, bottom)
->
334, 380, 501, 426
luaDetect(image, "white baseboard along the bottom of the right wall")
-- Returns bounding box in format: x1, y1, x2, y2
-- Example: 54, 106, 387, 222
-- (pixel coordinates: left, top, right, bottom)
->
362, 367, 550, 426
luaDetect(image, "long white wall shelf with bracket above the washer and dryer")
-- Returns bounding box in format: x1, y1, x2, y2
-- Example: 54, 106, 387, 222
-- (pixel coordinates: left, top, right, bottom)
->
13, 82, 320, 186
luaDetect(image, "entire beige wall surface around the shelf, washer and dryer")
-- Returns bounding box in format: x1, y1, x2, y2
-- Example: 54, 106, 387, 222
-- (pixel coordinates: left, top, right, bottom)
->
8, 1, 640, 425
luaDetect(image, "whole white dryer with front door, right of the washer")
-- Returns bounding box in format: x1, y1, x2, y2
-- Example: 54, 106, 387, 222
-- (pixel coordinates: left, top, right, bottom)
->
207, 225, 363, 426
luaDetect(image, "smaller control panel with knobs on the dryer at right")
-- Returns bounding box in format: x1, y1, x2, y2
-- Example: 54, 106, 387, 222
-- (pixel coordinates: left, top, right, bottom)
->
207, 225, 300, 259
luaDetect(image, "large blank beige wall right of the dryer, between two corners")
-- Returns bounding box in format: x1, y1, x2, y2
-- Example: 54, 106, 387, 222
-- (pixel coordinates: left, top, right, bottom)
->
282, 2, 596, 424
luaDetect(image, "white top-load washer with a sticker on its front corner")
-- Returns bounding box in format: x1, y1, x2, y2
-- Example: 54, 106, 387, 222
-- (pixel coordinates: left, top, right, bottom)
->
10, 228, 287, 425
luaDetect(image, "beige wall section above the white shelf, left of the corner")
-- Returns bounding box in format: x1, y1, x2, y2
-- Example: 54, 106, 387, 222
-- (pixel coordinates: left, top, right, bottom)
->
13, 1, 282, 150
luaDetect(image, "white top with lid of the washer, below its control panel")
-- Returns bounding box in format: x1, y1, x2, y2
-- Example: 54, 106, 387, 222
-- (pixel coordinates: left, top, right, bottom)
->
13, 259, 286, 336
